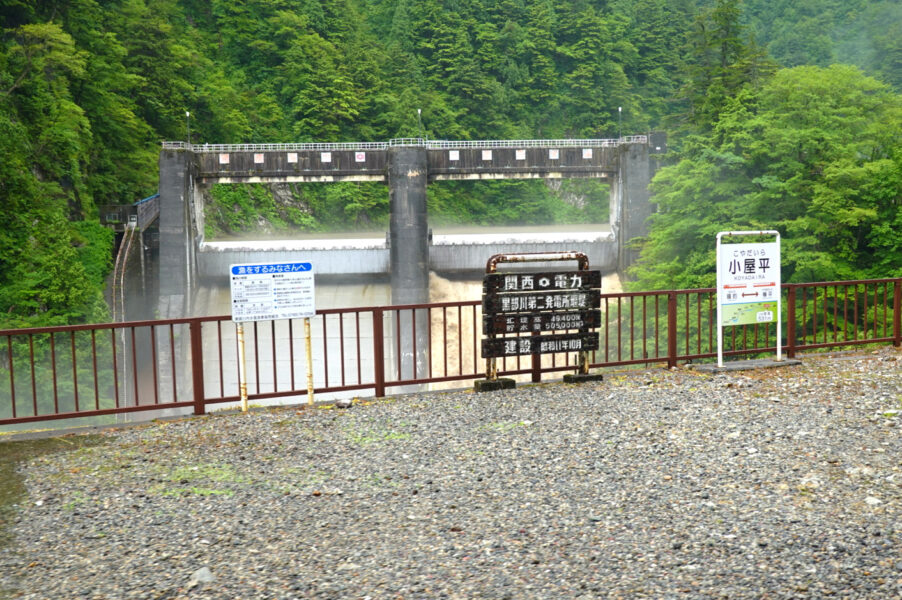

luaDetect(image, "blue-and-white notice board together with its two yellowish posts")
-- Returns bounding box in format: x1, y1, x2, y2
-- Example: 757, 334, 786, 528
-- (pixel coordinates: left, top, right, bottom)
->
229, 262, 316, 412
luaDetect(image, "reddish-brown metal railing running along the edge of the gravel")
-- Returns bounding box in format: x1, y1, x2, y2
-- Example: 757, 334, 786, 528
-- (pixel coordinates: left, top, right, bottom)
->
0, 278, 902, 425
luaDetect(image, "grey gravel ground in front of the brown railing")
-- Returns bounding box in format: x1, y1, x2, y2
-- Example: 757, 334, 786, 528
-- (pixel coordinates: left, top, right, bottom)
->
0, 348, 902, 599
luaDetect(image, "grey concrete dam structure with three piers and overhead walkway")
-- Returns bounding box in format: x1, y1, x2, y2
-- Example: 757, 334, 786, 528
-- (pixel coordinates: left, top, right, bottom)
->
159, 134, 666, 317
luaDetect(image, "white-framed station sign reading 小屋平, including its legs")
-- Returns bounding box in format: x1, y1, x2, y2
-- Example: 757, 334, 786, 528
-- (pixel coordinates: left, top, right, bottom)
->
717, 230, 782, 367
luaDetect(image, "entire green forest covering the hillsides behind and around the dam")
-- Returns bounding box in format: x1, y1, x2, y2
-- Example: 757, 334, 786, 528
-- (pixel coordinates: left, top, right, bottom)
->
0, 0, 902, 328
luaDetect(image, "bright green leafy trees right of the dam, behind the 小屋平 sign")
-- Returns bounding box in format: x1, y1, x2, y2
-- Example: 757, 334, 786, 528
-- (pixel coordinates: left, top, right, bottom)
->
632, 3, 902, 289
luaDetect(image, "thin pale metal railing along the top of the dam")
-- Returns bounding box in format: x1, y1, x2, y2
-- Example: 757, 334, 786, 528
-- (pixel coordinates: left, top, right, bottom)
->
163, 135, 648, 152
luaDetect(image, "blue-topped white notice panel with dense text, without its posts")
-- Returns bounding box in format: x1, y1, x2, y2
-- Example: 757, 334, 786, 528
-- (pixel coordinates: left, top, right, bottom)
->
229, 262, 316, 322
